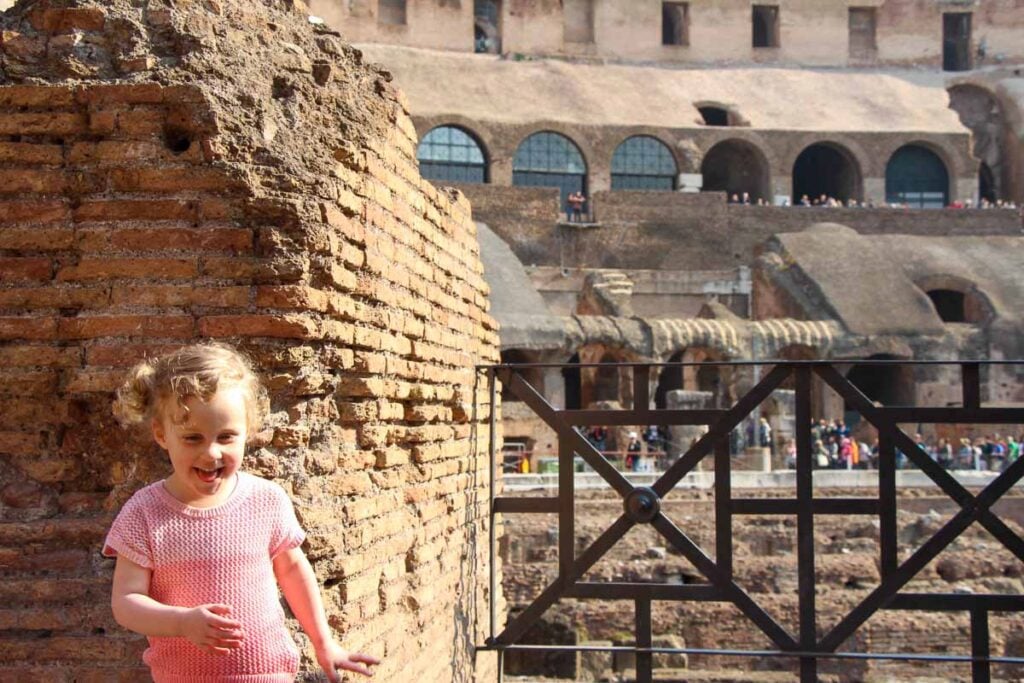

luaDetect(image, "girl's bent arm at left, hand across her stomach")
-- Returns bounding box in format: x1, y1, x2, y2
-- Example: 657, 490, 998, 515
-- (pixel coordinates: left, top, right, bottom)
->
111, 556, 244, 654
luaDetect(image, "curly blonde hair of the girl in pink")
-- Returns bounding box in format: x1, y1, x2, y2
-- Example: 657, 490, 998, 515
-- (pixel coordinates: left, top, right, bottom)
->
114, 342, 268, 437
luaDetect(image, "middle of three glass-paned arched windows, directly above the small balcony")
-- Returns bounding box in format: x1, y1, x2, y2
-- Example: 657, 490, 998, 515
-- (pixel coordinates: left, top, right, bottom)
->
512, 132, 587, 208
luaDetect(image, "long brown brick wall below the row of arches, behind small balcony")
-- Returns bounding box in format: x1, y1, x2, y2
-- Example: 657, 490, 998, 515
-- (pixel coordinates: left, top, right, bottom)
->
460, 185, 1021, 270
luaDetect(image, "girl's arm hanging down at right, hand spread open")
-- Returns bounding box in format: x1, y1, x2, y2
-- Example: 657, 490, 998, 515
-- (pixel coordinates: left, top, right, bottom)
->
273, 548, 380, 683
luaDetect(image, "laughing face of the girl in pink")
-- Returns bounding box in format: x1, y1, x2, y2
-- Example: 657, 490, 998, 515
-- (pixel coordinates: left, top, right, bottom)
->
153, 387, 247, 507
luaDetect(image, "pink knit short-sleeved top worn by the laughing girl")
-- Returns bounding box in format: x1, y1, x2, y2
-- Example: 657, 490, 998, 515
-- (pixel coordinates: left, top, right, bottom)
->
103, 472, 305, 683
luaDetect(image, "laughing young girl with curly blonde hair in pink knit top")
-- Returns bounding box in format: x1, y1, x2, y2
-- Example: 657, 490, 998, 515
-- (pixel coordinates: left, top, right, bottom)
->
103, 343, 378, 683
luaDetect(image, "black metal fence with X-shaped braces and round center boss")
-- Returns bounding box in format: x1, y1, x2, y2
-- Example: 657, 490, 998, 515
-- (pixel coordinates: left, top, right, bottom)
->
481, 361, 1024, 681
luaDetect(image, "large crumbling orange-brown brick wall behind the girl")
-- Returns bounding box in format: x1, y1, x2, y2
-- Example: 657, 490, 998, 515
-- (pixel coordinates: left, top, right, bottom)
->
0, 0, 498, 681
